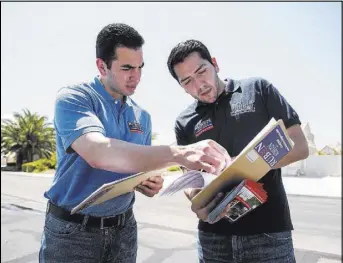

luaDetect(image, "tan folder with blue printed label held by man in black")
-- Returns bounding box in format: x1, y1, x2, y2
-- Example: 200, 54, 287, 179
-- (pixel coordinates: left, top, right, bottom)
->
192, 118, 293, 210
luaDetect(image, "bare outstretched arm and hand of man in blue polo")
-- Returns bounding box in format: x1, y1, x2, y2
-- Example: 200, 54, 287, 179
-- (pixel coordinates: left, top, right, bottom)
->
71, 132, 229, 173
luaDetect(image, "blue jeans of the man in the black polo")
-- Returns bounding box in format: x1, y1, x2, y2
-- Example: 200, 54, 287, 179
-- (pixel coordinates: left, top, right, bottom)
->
197, 231, 295, 263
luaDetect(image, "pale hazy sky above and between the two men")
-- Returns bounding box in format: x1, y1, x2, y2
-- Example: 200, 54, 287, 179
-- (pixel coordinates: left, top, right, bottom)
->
1, 2, 342, 148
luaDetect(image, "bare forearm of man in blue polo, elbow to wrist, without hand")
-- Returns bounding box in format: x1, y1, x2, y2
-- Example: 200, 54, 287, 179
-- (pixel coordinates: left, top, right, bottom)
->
92, 138, 180, 173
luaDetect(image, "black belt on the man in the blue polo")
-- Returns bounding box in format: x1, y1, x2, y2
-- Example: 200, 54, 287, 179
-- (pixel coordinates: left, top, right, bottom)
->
47, 202, 133, 229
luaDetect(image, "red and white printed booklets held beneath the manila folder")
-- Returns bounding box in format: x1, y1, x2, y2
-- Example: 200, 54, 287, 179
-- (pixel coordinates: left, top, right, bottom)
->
208, 179, 267, 223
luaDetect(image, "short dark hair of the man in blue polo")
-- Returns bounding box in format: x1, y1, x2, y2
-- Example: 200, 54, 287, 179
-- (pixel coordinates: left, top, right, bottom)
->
96, 23, 144, 68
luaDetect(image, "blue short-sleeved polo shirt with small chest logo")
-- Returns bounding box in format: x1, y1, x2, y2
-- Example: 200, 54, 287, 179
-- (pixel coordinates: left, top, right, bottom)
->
44, 77, 151, 216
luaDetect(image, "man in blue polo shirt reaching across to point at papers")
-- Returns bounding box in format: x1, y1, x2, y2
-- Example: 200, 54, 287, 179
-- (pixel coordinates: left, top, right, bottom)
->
39, 24, 229, 263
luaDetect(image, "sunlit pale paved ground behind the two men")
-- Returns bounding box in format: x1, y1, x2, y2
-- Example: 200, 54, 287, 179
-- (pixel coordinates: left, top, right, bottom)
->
1, 173, 341, 263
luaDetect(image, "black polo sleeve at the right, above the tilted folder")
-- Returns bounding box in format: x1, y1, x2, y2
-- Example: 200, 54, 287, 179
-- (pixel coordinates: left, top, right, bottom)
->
262, 80, 301, 128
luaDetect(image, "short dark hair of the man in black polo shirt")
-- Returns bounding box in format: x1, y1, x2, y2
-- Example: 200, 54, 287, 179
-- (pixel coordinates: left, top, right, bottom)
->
167, 39, 213, 81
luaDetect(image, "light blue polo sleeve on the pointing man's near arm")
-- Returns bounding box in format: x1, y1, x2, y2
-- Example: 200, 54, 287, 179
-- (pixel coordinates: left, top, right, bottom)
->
54, 88, 106, 153
